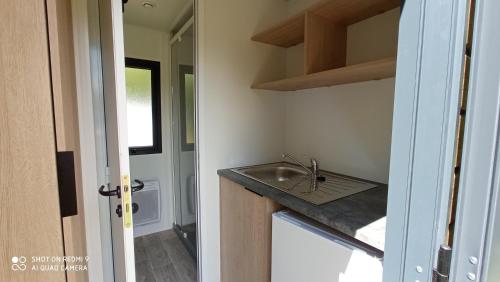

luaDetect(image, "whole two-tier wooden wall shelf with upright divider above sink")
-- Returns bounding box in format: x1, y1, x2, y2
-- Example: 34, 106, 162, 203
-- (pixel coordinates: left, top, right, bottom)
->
252, 0, 400, 91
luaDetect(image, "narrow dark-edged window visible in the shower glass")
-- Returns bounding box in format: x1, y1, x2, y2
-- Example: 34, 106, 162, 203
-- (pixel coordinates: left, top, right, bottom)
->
179, 65, 195, 151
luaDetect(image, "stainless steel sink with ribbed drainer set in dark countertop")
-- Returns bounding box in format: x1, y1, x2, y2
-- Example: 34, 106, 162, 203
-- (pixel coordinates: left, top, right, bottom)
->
232, 162, 377, 205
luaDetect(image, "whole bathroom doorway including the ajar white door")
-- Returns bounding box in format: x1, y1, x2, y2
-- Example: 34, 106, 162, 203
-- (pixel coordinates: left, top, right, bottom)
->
89, 0, 197, 281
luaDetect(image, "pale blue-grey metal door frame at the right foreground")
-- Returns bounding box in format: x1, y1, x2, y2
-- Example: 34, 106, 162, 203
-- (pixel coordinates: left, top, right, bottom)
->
384, 0, 469, 281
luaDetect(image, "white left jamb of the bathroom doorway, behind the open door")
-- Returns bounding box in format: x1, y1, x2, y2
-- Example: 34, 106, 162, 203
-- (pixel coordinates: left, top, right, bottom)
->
71, 0, 109, 281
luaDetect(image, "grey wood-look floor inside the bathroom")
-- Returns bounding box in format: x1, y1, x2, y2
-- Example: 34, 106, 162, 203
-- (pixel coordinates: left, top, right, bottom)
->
135, 230, 196, 282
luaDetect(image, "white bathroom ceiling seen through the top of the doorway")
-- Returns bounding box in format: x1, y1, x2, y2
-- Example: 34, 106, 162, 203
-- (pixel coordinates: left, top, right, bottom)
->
123, 0, 191, 32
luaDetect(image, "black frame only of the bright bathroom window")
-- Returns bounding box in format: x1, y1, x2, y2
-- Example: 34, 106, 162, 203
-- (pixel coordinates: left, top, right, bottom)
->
125, 57, 162, 155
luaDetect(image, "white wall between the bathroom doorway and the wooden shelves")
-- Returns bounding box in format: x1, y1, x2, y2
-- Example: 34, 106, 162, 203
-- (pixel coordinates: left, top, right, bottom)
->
197, 0, 286, 282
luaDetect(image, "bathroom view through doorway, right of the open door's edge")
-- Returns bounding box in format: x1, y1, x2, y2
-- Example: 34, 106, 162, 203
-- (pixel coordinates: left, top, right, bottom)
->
121, 0, 197, 281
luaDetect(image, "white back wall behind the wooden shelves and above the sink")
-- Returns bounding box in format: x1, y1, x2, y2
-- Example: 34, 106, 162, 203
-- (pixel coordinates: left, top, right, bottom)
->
284, 7, 399, 183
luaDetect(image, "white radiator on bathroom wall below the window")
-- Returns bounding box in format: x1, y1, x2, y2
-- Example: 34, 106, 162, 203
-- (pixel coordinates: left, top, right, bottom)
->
132, 180, 161, 226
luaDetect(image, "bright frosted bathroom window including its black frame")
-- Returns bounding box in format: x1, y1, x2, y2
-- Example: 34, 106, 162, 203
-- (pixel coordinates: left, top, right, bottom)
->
125, 58, 161, 155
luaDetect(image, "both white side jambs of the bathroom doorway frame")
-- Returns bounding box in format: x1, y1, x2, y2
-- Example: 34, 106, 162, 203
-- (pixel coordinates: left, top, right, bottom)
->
71, 0, 202, 282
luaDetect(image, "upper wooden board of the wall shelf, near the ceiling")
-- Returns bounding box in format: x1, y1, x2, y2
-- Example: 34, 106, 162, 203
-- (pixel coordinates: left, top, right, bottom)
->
252, 0, 401, 48
